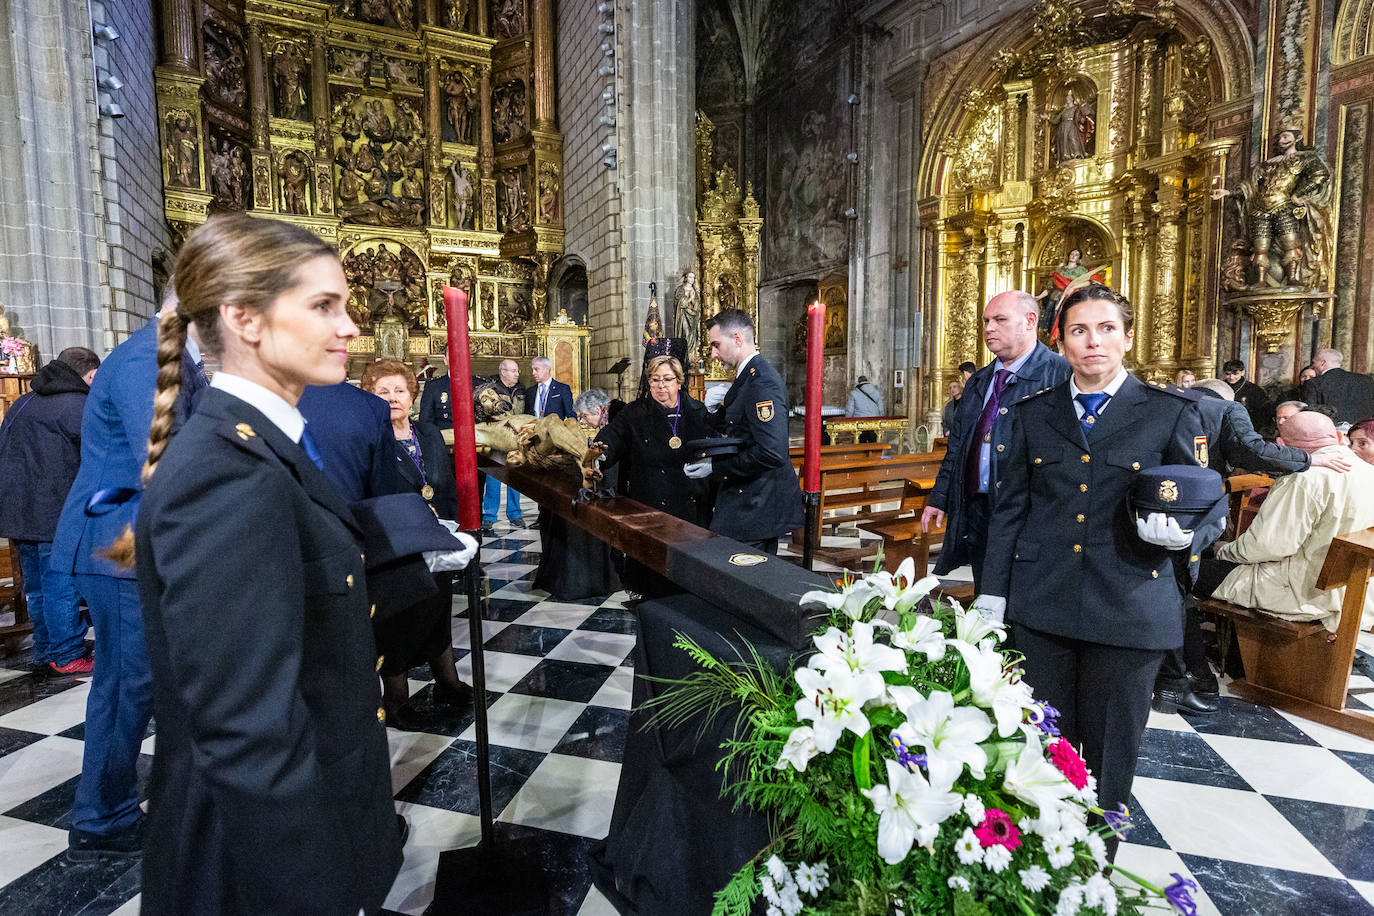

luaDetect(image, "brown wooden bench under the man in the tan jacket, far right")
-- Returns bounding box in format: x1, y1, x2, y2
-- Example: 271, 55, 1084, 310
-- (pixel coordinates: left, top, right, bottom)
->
1198, 527, 1374, 740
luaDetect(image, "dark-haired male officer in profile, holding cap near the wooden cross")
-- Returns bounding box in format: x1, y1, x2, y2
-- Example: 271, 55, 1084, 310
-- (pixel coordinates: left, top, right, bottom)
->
683, 309, 802, 553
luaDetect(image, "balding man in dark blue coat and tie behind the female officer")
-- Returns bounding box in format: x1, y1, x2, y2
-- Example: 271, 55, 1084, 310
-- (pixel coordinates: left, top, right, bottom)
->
921, 290, 1069, 593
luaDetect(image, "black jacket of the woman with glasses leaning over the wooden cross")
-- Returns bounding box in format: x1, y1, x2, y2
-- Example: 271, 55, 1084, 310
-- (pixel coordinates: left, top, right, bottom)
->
596, 391, 710, 526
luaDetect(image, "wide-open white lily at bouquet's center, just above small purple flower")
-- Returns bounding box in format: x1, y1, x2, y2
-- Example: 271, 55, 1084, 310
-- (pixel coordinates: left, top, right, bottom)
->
888, 687, 992, 785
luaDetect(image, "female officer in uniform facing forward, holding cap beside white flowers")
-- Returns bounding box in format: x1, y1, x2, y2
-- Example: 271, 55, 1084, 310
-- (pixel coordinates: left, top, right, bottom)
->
978, 283, 1206, 840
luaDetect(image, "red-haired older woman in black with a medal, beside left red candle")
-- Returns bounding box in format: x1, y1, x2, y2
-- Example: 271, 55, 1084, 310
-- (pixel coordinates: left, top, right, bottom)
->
363, 360, 473, 731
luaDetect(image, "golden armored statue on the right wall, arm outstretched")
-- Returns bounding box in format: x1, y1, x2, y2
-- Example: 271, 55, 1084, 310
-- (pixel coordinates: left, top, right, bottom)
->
1212, 128, 1331, 288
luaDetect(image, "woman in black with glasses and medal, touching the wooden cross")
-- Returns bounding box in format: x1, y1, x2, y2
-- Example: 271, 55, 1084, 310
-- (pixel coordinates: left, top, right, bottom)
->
594, 356, 710, 595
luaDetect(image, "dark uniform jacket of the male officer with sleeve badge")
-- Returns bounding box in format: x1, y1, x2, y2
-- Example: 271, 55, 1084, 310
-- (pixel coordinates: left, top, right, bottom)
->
708, 353, 802, 541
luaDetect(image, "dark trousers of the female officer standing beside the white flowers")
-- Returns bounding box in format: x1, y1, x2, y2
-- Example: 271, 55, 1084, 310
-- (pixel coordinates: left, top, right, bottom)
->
1013, 623, 1164, 834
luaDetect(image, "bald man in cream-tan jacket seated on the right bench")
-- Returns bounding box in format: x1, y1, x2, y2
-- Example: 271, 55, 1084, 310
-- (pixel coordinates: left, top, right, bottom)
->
1193, 411, 1374, 633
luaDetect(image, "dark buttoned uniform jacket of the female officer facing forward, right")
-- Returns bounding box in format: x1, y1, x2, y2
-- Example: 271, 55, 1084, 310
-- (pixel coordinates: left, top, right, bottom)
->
982, 375, 1206, 650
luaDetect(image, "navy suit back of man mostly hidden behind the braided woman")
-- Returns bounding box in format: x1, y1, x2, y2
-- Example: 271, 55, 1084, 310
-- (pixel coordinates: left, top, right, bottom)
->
297, 379, 401, 503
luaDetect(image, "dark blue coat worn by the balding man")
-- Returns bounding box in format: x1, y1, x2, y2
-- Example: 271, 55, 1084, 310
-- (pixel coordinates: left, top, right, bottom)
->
926, 341, 1069, 575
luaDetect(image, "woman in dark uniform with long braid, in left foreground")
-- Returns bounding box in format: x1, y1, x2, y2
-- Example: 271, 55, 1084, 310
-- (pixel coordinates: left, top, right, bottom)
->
135, 213, 401, 915
